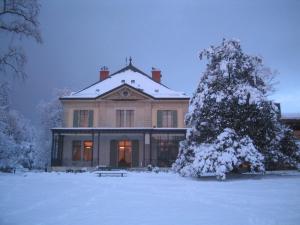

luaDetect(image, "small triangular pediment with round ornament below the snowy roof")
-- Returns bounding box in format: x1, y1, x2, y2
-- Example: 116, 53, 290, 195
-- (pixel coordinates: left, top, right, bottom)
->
101, 85, 151, 100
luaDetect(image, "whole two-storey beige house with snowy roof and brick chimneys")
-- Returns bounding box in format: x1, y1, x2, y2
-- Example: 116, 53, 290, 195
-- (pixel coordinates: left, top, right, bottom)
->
51, 59, 189, 167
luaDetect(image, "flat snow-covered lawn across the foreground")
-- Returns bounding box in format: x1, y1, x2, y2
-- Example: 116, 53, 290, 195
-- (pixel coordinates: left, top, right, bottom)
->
0, 172, 300, 225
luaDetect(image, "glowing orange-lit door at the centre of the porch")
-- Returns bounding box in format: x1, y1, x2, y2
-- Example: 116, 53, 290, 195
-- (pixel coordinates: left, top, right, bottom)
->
118, 140, 132, 167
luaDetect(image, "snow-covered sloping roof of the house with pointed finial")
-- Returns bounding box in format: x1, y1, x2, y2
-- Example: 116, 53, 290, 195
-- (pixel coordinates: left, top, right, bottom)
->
62, 63, 189, 99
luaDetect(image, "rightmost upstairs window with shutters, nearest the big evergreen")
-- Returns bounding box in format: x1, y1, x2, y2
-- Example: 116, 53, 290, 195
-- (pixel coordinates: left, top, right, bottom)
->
157, 110, 177, 127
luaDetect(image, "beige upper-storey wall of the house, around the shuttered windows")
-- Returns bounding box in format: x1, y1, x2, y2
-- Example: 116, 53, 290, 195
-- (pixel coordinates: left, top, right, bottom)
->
62, 92, 188, 128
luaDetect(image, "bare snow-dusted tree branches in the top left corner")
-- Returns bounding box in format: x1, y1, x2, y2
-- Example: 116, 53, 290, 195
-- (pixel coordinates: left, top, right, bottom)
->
0, 0, 42, 78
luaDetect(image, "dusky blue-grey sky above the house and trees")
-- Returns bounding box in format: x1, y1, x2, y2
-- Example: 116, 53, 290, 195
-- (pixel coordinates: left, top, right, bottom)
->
6, 0, 300, 121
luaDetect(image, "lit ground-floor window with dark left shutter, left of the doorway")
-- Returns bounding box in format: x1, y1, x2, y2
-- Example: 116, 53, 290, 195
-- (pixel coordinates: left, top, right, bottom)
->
72, 140, 93, 161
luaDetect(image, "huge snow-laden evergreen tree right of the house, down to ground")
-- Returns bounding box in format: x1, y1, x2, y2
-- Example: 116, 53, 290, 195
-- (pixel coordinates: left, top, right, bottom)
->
173, 39, 299, 179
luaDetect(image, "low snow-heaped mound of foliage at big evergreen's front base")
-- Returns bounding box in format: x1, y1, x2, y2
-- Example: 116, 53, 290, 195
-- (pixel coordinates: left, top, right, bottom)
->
180, 128, 264, 179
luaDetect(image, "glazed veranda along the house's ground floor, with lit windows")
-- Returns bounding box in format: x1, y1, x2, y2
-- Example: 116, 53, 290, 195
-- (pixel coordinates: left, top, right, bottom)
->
51, 128, 186, 168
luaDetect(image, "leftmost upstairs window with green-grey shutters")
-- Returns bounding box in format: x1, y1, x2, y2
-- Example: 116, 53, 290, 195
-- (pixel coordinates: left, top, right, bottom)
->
73, 110, 94, 127
